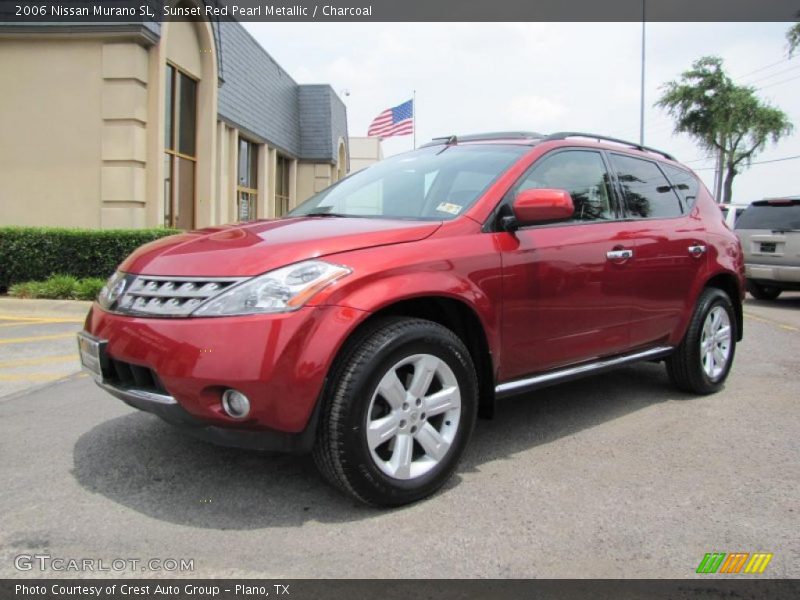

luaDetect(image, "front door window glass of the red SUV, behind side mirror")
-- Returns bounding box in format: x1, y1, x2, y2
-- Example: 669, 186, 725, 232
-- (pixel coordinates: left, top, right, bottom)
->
515, 150, 615, 221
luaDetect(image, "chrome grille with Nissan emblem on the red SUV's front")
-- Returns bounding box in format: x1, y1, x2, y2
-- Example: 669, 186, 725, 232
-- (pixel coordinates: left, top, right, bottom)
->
112, 275, 247, 317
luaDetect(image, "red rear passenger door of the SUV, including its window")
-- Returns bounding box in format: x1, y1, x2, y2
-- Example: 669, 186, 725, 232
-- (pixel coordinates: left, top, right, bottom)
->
609, 152, 708, 349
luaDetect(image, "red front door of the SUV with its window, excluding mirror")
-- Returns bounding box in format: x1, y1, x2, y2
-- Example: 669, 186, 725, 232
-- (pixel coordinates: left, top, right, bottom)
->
495, 148, 633, 380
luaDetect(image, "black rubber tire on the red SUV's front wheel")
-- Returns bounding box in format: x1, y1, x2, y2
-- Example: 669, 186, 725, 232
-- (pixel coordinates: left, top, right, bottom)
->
313, 317, 478, 506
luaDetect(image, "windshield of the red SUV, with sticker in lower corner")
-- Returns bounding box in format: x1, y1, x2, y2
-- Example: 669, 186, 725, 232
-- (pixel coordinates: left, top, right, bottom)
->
287, 144, 530, 221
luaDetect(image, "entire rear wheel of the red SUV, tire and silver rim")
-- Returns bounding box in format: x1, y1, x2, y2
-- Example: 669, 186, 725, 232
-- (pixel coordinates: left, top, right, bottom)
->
667, 288, 737, 394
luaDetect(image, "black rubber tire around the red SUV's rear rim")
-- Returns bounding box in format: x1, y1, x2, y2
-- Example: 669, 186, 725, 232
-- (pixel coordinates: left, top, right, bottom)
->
666, 288, 738, 394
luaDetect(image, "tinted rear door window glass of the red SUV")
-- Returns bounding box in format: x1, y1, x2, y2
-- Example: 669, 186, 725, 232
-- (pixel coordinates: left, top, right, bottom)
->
611, 154, 681, 219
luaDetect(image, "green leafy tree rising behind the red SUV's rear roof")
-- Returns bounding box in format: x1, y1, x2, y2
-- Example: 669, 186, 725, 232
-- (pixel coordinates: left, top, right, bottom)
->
655, 56, 793, 203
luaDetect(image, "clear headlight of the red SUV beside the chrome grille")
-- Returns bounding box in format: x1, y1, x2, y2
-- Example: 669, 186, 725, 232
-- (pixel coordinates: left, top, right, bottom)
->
192, 260, 351, 317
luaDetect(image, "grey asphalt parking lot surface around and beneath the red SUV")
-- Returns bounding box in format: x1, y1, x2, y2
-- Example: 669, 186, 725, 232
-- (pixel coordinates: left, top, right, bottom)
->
0, 294, 800, 578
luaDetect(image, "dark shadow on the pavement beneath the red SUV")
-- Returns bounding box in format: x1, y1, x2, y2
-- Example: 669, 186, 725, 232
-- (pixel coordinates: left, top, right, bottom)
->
73, 364, 686, 530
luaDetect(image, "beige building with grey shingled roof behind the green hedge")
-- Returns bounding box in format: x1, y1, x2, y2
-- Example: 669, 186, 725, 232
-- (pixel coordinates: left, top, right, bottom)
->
0, 14, 349, 229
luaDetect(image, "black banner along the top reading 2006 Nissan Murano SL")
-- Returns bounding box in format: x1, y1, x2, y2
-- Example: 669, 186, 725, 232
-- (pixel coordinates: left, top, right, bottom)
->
0, 0, 800, 25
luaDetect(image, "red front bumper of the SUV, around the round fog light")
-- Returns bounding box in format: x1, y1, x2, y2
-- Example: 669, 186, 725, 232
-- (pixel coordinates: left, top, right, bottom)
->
85, 304, 363, 451
